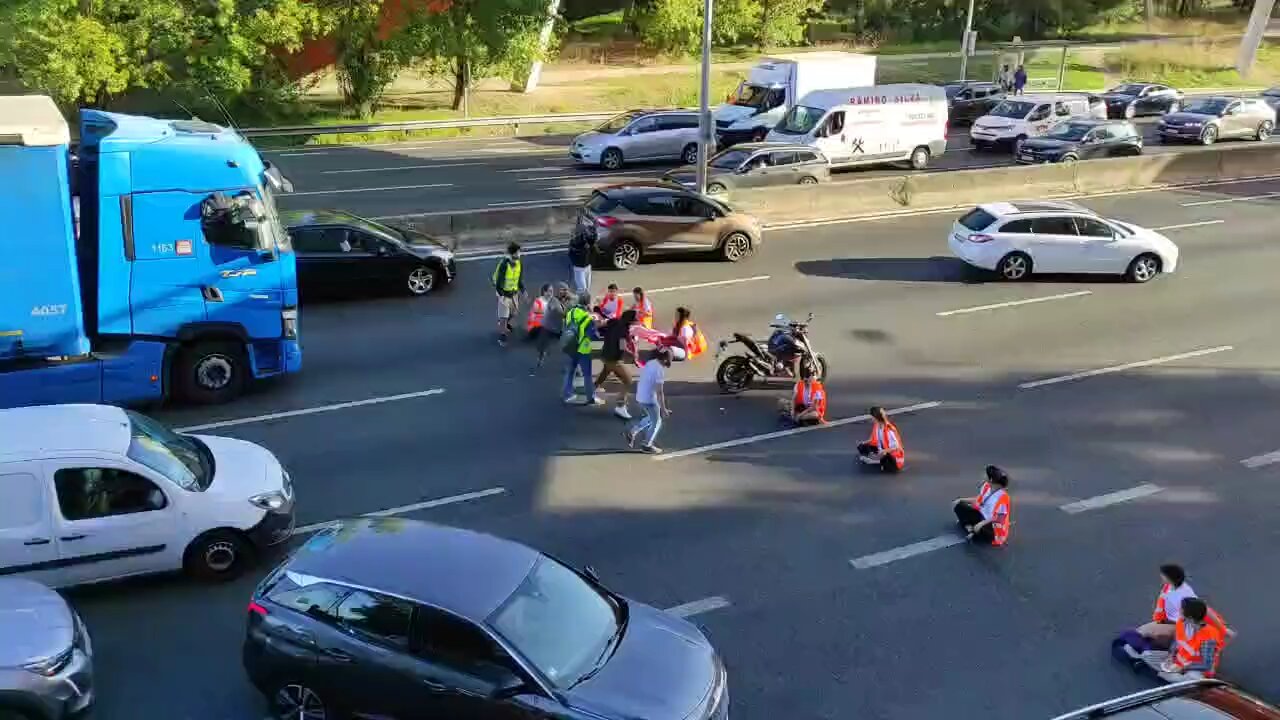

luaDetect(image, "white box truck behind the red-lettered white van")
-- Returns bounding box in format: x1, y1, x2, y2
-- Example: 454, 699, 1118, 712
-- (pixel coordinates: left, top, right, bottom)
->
712, 53, 876, 147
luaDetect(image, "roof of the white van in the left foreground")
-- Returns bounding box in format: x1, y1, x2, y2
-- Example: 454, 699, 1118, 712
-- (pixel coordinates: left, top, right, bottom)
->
0, 405, 132, 460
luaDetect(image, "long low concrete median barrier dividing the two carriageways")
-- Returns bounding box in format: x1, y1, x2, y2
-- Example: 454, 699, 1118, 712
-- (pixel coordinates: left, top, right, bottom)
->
407, 143, 1280, 249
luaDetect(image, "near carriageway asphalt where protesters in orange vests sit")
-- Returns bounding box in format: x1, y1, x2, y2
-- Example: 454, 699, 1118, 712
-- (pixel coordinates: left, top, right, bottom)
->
69, 175, 1280, 720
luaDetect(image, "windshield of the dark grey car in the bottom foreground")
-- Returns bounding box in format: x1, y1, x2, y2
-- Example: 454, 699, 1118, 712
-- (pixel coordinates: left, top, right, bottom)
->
488, 557, 625, 689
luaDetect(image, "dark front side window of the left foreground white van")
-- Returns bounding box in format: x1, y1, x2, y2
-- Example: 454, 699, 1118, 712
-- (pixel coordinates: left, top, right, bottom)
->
54, 468, 166, 520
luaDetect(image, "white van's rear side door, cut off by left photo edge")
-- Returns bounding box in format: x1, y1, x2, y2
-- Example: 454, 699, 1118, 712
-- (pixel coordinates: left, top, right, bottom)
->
0, 464, 58, 584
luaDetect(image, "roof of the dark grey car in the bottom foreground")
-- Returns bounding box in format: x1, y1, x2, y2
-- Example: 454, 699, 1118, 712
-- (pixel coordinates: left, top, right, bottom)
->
285, 518, 541, 623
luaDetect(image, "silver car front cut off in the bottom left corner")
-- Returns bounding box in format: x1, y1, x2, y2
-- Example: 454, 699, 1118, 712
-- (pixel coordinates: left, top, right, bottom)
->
0, 573, 93, 720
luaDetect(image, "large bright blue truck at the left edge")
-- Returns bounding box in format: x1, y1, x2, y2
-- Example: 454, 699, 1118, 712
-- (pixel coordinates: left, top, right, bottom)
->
0, 96, 302, 407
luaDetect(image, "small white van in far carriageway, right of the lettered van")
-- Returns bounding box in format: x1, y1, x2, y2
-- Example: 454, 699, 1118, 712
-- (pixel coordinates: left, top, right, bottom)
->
969, 92, 1107, 150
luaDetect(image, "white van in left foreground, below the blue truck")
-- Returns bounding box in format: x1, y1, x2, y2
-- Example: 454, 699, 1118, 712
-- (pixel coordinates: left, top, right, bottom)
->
0, 405, 293, 587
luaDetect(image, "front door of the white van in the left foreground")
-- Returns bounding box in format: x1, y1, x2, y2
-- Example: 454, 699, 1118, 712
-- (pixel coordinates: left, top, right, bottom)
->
45, 459, 177, 585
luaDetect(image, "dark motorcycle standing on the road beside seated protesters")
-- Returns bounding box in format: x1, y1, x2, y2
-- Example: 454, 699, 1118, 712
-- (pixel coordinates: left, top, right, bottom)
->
716, 313, 827, 393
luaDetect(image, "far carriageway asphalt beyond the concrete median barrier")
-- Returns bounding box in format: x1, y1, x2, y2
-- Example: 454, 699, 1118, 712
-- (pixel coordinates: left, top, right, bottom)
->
268, 96, 1280, 218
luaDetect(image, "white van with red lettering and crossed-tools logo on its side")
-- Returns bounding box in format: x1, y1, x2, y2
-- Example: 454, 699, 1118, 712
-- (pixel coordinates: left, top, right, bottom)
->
768, 83, 947, 170
